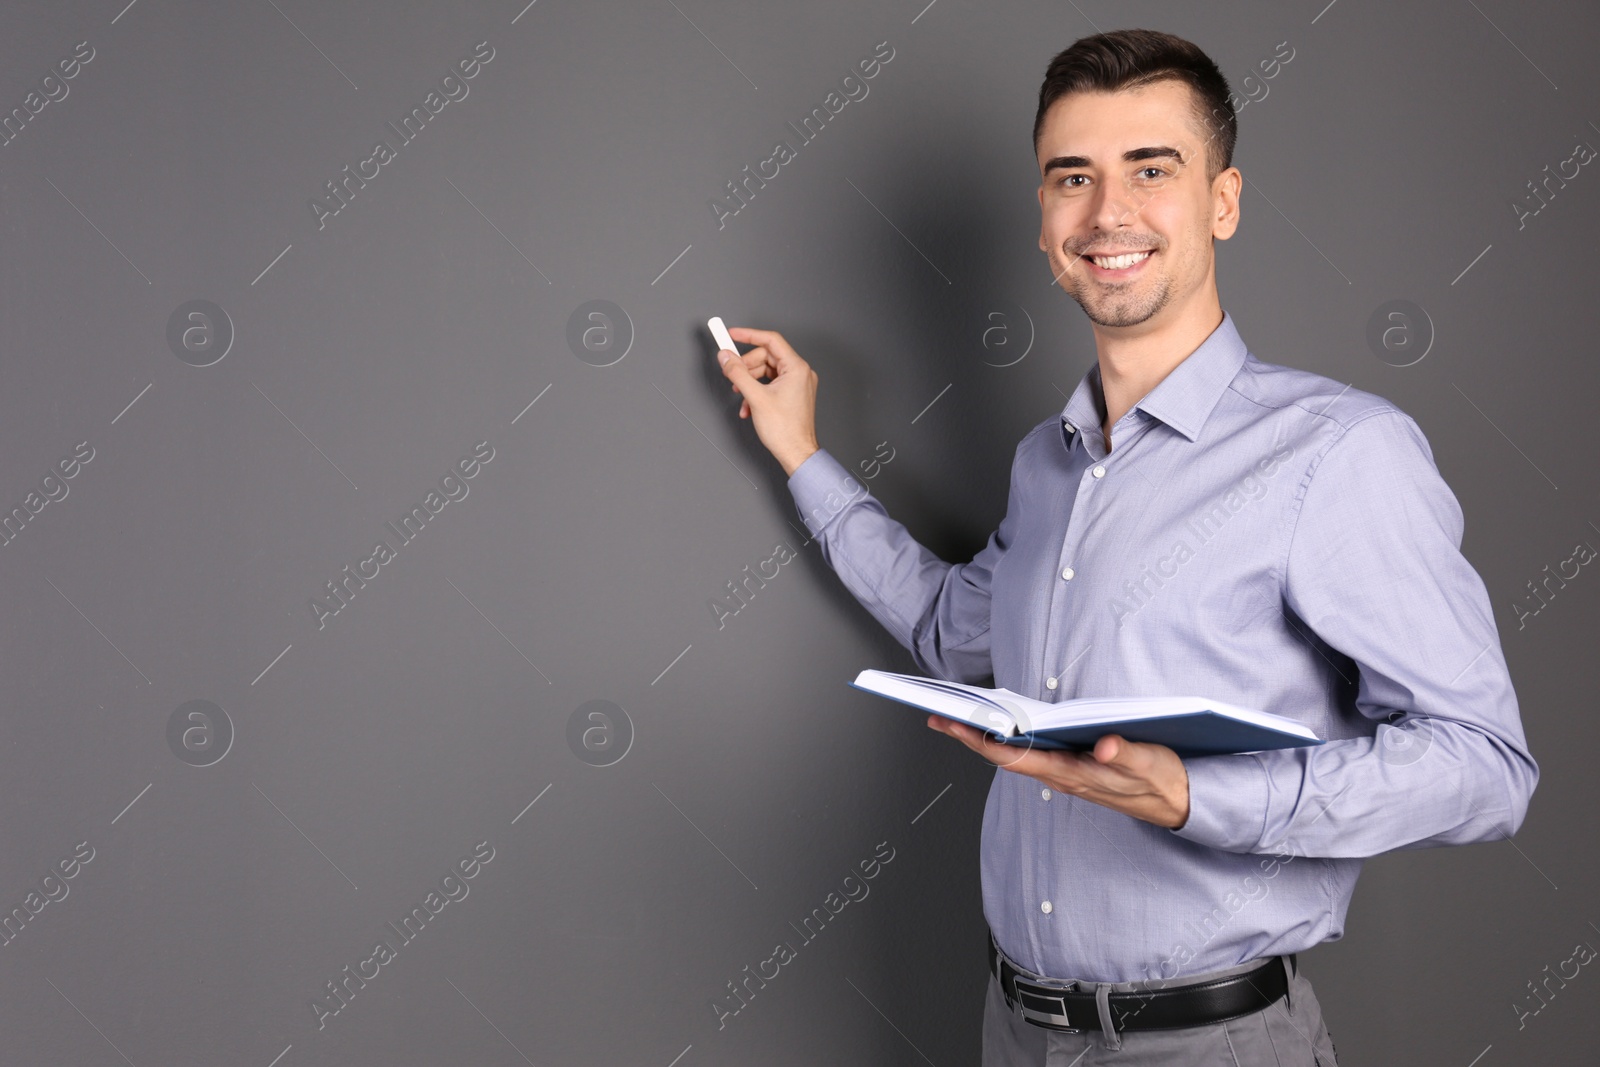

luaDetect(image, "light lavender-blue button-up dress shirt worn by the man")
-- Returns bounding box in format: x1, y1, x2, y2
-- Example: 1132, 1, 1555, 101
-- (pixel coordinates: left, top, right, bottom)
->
789, 314, 1539, 982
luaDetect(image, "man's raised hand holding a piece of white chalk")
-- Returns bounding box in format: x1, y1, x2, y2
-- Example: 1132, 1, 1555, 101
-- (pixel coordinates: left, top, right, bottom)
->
717, 326, 819, 475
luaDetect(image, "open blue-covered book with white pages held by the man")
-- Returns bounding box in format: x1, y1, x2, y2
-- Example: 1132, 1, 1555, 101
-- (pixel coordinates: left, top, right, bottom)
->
850, 670, 1323, 757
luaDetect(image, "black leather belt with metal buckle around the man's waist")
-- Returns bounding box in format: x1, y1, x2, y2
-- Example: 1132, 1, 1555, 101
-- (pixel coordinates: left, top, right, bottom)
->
989, 934, 1298, 1033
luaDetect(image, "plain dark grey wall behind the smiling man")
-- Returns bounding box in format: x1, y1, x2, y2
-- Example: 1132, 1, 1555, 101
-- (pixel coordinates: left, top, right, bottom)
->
0, 0, 1600, 1067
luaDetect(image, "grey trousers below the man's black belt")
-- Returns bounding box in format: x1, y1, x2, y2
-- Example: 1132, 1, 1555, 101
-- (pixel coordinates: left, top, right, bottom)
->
982, 958, 1338, 1067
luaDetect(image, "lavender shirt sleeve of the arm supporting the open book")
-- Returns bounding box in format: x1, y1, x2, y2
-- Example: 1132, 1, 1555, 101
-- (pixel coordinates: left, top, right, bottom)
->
1174, 408, 1539, 857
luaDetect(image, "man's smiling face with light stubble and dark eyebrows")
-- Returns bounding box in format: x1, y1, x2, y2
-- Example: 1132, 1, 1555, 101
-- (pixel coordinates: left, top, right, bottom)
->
1038, 80, 1242, 326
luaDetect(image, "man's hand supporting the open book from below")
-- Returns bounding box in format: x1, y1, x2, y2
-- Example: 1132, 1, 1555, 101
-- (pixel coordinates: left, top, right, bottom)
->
928, 715, 1189, 830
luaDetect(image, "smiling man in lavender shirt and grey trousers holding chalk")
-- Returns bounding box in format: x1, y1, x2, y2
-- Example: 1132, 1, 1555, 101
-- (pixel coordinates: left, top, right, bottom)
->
718, 30, 1539, 1067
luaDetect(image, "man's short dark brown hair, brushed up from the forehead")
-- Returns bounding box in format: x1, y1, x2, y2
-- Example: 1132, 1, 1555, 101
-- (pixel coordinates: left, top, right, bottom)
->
1034, 30, 1238, 181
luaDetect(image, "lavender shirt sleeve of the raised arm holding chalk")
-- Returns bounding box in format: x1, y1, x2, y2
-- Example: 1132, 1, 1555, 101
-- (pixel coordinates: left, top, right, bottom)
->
789, 450, 1016, 685
